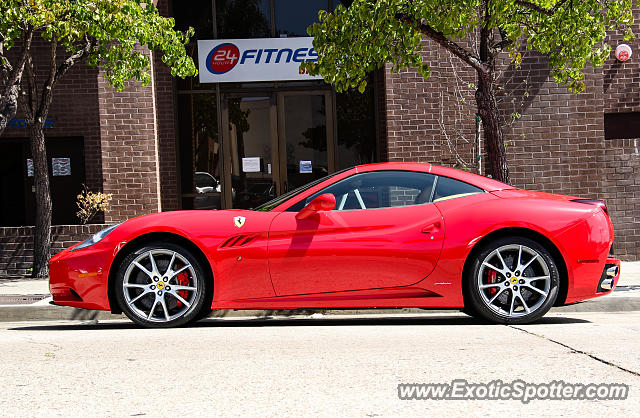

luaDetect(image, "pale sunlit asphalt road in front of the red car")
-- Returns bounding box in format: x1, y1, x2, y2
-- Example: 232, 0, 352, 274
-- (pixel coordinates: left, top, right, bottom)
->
0, 312, 640, 416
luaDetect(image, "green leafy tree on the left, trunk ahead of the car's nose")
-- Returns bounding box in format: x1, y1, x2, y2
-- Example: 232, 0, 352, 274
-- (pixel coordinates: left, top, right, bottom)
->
0, 0, 197, 277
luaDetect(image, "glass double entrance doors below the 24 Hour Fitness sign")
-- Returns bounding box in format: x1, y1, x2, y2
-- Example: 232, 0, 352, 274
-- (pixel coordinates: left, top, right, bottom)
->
223, 91, 336, 209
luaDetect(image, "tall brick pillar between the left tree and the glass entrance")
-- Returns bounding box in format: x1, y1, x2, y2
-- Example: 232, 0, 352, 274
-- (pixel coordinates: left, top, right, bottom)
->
98, 0, 179, 222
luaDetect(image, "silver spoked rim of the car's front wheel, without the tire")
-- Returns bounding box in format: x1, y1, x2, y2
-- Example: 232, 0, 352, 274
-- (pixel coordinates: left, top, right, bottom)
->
122, 249, 199, 322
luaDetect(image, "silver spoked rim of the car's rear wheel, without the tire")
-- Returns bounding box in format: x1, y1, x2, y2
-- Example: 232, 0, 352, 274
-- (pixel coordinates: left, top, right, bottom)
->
476, 244, 551, 318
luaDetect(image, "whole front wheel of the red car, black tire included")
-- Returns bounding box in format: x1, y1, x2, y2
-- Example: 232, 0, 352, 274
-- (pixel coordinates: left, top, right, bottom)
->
114, 242, 210, 328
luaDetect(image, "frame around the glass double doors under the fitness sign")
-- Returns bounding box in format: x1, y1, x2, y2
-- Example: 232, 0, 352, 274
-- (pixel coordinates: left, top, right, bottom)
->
220, 89, 338, 209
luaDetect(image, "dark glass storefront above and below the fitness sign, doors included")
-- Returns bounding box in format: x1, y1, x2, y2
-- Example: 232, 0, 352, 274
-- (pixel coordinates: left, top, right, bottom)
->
173, 0, 377, 209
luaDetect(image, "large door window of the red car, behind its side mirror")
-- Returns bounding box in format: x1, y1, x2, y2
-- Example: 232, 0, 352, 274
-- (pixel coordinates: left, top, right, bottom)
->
287, 170, 435, 212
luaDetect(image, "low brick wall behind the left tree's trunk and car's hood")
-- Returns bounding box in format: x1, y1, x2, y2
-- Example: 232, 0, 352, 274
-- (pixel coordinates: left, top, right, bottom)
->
0, 224, 106, 277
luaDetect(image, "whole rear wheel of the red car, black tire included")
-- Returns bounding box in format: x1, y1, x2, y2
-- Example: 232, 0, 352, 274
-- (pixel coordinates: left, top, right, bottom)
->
464, 236, 560, 325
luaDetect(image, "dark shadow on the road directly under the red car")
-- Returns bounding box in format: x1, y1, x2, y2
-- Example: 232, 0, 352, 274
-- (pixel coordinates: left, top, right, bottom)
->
9, 315, 591, 331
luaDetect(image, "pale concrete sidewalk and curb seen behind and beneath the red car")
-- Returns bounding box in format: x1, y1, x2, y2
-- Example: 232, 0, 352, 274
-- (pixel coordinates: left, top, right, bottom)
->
0, 261, 640, 321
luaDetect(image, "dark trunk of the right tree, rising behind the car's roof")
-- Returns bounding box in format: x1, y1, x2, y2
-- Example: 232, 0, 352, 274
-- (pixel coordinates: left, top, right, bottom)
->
476, 71, 509, 184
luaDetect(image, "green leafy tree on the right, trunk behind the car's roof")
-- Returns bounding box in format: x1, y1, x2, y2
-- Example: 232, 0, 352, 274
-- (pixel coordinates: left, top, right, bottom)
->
302, 0, 633, 183
